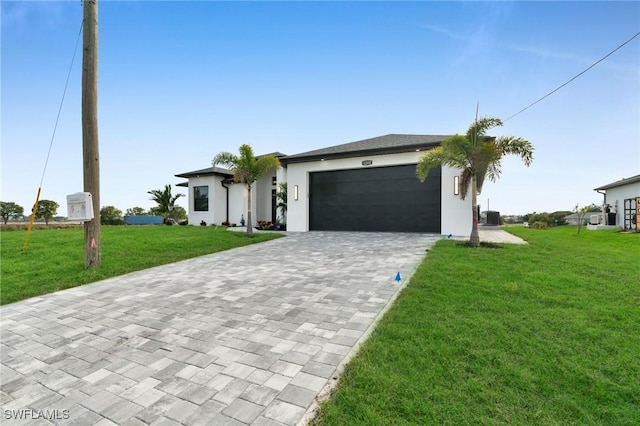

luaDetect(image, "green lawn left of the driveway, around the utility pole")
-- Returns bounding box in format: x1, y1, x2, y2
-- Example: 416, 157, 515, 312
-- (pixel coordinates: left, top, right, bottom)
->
0, 226, 279, 304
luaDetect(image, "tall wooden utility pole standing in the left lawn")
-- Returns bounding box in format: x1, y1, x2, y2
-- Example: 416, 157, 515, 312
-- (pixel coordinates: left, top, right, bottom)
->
82, 0, 100, 268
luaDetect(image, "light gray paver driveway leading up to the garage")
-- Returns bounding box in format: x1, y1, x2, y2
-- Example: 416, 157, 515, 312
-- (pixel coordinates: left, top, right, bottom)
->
0, 232, 440, 426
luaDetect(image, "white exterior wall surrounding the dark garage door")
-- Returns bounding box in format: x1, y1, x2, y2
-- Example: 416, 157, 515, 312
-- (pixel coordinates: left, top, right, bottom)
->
286, 151, 472, 238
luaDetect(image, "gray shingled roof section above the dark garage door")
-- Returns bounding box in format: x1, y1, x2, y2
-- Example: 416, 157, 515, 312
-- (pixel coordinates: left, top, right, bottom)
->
282, 134, 451, 163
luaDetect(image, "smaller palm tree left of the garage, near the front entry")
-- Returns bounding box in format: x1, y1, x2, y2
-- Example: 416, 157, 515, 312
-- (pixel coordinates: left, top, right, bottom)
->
212, 144, 280, 237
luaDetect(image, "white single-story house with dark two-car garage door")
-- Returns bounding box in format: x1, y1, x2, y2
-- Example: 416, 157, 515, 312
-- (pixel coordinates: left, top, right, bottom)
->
176, 134, 472, 237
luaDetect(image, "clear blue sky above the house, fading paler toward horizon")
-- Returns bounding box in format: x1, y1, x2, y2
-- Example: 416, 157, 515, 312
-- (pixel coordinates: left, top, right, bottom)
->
0, 0, 640, 215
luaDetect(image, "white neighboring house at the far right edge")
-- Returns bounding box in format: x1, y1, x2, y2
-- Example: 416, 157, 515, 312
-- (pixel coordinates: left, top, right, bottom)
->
594, 175, 640, 230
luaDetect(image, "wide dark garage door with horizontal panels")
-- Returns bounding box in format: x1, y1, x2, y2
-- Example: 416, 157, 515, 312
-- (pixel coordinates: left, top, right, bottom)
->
309, 165, 441, 233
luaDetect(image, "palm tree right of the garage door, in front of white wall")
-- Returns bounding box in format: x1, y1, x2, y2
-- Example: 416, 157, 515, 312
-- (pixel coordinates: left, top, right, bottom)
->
416, 117, 534, 247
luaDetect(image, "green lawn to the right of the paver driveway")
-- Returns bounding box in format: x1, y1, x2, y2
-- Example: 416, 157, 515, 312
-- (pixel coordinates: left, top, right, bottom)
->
314, 227, 640, 425
